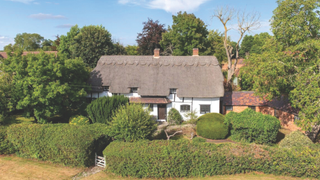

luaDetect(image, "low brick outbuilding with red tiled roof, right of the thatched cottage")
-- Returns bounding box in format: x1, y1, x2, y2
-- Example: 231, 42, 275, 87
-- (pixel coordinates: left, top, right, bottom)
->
221, 91, 300, 130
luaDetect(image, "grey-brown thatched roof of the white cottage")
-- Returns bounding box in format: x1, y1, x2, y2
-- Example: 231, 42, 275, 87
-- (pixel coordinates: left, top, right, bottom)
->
89, 56, 224, 97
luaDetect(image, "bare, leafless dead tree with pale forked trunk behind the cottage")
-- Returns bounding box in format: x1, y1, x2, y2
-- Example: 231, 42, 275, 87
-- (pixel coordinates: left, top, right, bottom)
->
213, 7, 260, 85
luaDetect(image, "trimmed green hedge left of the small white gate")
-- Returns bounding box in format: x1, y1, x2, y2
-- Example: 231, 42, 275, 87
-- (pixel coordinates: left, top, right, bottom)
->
7, 124, 110, 167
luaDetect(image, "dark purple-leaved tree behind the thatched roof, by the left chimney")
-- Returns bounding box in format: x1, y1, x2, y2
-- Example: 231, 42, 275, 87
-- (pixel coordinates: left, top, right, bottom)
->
136, 19, 166, 55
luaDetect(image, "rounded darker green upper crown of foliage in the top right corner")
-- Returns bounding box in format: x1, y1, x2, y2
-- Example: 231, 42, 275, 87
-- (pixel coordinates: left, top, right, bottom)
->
271, 0, 320, 46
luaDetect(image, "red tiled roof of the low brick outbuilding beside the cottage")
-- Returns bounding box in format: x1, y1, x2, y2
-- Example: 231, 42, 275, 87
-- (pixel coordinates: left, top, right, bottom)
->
223, 91, 299, 114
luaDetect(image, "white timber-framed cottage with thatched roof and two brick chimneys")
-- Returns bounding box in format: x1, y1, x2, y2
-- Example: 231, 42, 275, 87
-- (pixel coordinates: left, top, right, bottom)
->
88, 48, 224, 120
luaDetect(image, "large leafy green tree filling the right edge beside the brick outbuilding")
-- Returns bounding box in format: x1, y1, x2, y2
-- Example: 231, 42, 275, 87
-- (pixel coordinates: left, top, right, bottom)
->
241, 0, 320, 138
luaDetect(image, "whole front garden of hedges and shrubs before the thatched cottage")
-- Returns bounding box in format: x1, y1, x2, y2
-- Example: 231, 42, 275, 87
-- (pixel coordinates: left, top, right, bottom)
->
0, 96, 320, 178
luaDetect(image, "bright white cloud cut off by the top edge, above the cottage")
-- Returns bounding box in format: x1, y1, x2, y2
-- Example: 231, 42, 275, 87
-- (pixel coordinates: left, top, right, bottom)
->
118, 0, 209, 13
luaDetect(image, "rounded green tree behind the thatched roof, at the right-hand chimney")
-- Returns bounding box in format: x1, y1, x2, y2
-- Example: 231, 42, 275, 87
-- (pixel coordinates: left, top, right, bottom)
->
160, 12, 209, 56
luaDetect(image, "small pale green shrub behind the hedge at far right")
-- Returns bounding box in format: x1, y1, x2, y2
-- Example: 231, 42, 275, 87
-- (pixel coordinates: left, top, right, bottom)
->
279, 131, 313, 148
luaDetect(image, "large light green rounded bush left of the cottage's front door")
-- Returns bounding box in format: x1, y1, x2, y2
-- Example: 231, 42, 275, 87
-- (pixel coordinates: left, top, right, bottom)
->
108, 103, 157, 142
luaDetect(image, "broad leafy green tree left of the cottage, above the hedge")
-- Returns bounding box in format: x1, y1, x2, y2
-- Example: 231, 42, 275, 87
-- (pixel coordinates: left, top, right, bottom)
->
1, 51, 89, 123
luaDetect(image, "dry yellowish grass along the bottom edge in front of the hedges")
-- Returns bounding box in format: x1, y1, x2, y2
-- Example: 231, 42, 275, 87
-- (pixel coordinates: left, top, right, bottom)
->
0, 156, 308, 180
